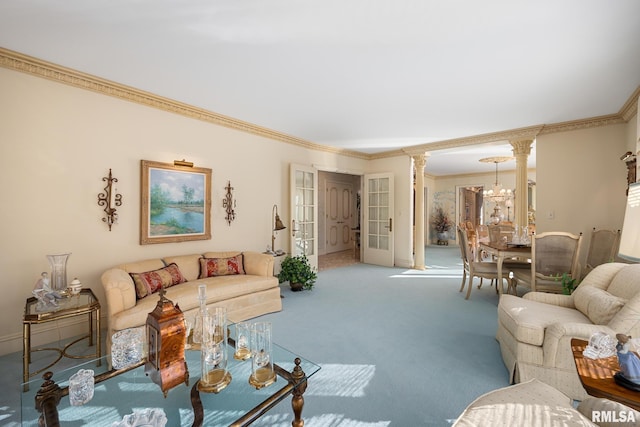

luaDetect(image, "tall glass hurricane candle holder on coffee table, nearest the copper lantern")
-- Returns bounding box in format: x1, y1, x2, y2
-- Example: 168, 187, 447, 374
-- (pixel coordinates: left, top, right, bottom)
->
198, 307, 231, 393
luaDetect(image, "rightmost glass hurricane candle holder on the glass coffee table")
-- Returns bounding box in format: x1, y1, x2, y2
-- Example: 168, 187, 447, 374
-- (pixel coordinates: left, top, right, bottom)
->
249, 322, 276, 390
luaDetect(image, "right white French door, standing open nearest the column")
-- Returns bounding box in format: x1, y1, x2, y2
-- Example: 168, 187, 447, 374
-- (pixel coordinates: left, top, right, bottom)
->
361, 173, 394, 267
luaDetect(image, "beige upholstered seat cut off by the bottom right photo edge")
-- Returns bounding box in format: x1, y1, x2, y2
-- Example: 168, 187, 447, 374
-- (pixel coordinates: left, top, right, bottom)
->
453, 379, 640, 427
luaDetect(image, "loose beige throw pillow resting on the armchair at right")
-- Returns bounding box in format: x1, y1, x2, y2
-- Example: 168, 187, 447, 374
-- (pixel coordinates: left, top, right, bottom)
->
573, 286, 627, 325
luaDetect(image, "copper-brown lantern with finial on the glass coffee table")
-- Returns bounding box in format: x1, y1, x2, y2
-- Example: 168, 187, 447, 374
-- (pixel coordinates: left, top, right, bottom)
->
144, 288, 189, 397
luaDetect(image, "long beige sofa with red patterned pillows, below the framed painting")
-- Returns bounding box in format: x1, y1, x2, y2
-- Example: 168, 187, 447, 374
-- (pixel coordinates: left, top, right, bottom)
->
102, 252, 282, 355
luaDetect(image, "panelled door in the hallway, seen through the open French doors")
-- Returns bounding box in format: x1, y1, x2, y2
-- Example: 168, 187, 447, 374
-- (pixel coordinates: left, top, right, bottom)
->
325, 181, 353, 254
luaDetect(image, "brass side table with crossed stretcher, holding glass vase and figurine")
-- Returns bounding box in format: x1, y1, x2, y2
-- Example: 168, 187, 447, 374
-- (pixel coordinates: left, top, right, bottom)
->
22, 289, 102, 391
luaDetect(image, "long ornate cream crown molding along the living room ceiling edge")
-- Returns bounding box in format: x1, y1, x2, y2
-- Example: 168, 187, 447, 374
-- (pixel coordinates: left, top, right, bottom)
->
0, 47, 640, 160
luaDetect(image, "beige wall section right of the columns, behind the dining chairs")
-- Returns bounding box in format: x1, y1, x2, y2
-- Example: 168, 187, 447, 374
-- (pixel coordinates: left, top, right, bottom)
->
536, 120, 635, 272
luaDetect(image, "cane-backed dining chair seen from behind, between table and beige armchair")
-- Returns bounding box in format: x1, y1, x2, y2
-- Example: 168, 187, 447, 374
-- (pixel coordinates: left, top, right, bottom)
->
511, 231, 582, 293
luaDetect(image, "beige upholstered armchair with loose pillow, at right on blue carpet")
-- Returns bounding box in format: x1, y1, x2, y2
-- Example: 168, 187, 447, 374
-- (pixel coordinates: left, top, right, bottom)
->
496, 263, 640, 400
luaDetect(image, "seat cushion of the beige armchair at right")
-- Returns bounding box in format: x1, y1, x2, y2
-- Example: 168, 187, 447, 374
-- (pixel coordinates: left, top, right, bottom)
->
498, 294, 591, 346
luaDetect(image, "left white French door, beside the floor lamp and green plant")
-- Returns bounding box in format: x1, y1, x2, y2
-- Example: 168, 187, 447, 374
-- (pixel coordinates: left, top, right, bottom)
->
289, 164, 318, 268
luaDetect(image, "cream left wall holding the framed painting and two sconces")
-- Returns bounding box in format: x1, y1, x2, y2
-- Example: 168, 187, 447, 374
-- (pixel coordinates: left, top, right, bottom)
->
0, 68, 376, 354
